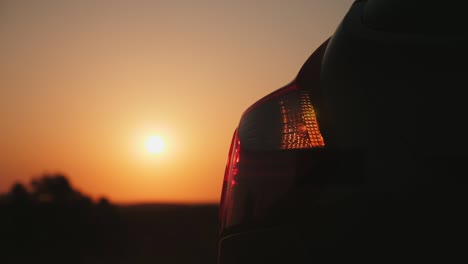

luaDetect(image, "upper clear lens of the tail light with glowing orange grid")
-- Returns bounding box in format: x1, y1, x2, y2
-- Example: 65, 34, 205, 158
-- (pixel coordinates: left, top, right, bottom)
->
238, 82, 325, 150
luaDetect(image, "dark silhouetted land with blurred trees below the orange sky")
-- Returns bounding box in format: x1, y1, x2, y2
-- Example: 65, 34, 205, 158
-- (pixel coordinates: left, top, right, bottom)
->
0, 177, 218, 264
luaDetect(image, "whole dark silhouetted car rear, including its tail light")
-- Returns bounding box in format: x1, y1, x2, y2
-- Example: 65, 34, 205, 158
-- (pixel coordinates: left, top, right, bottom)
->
218, 0, 468, 264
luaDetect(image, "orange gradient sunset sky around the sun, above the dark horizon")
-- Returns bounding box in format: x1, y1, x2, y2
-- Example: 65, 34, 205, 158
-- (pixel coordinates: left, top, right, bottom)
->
0, 0, 352, 203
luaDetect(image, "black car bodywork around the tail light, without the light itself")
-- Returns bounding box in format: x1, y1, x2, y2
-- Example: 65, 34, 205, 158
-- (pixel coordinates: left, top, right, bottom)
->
219, 1, 468, 264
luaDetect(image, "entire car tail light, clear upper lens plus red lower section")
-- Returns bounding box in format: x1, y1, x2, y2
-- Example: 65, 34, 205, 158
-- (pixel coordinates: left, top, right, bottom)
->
220, 82, 325, 231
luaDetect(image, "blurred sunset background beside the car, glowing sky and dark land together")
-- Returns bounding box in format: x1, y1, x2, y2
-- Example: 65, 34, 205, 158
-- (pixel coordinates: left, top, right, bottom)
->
0, 0, 352, 263
